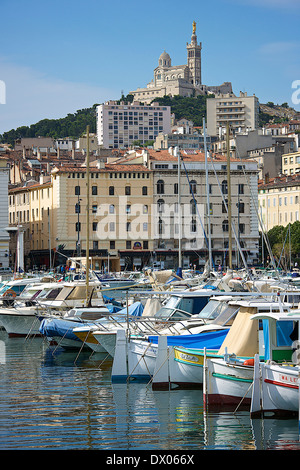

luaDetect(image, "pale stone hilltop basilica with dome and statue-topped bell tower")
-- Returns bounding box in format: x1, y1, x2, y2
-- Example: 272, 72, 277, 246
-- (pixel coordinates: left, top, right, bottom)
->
130, 21, 232, 104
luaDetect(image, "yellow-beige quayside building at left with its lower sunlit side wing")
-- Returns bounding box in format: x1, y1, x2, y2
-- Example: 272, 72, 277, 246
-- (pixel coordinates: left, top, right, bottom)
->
9, 161, 153, 271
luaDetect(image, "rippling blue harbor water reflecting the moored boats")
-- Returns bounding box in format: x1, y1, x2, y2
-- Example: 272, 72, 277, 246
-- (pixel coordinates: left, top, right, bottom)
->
0, 330, 300, 454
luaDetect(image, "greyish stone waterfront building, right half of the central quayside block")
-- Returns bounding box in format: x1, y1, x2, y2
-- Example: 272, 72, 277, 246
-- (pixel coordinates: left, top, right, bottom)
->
149, 150, 258, 267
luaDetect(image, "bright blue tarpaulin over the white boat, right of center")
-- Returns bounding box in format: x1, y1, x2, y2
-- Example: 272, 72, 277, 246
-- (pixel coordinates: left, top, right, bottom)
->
148, 329, 229, 349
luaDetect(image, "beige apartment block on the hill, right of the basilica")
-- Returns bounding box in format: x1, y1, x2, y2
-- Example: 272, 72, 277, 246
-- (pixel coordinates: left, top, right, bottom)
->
207, 92, 259, 135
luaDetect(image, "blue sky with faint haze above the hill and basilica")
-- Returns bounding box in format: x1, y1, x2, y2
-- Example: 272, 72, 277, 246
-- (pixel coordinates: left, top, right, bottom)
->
0, 0, 300, 134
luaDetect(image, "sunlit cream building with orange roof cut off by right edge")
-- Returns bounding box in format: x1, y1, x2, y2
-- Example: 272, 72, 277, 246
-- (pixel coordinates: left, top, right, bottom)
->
258, 174, 300, 231
